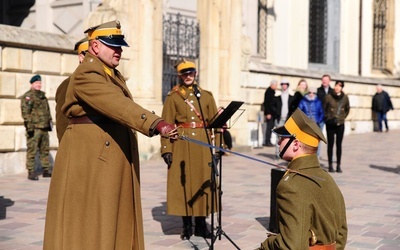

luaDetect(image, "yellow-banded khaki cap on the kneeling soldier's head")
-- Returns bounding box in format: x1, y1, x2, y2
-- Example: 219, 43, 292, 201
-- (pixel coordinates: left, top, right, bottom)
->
272, 109, 326, 147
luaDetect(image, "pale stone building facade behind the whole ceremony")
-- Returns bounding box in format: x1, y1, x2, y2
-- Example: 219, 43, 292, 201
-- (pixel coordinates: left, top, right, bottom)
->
0, 0, 400, 175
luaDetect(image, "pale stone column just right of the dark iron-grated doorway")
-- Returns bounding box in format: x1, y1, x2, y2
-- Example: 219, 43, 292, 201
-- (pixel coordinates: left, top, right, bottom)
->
197, 0, 249, 145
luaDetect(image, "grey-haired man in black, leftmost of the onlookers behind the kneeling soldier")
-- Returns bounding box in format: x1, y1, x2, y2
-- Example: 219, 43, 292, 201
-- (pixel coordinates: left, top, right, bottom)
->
263, 80, 278, 147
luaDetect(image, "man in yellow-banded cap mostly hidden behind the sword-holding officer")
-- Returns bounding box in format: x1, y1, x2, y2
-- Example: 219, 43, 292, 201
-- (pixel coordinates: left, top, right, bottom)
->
56, 37, 89, 143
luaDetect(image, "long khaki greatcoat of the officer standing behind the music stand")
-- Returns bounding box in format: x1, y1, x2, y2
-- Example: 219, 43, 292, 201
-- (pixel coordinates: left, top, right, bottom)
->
161, 85, 219, 216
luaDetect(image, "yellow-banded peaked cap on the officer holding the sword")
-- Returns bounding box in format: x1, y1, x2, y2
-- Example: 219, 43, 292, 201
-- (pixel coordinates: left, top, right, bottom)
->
85, 20, 129, 47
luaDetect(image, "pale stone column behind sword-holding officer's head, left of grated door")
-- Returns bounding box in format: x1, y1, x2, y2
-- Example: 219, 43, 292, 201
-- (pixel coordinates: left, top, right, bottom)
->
86, 0, 162, 105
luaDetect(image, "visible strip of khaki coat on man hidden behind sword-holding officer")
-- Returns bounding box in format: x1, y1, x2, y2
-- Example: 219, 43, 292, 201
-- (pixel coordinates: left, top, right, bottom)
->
56, 77, 71, 143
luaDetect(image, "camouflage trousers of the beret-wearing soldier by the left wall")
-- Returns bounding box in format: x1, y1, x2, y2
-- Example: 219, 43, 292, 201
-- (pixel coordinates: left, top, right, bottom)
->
26, 129, 50, 172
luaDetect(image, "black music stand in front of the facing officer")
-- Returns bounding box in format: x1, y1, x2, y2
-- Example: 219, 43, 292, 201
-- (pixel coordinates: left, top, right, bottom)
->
207, 101, 244, 249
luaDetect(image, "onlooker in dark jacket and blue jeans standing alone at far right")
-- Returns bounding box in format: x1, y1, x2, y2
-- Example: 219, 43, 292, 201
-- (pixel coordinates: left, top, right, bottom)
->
372, 84, 394, 132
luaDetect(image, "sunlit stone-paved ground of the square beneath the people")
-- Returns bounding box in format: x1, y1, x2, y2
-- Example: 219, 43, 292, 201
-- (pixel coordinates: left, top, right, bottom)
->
0, 130, 400, 250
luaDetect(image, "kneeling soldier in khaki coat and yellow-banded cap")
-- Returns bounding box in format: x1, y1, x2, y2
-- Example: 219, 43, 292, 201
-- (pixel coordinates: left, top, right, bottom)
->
258, 109, 347, 250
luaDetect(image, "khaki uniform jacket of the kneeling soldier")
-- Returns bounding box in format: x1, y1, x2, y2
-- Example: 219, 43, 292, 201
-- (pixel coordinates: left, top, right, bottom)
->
260, 154, 347, 250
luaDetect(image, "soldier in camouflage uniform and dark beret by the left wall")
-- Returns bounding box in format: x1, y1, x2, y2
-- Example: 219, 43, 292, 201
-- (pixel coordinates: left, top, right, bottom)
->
21, 75, 52, 181
